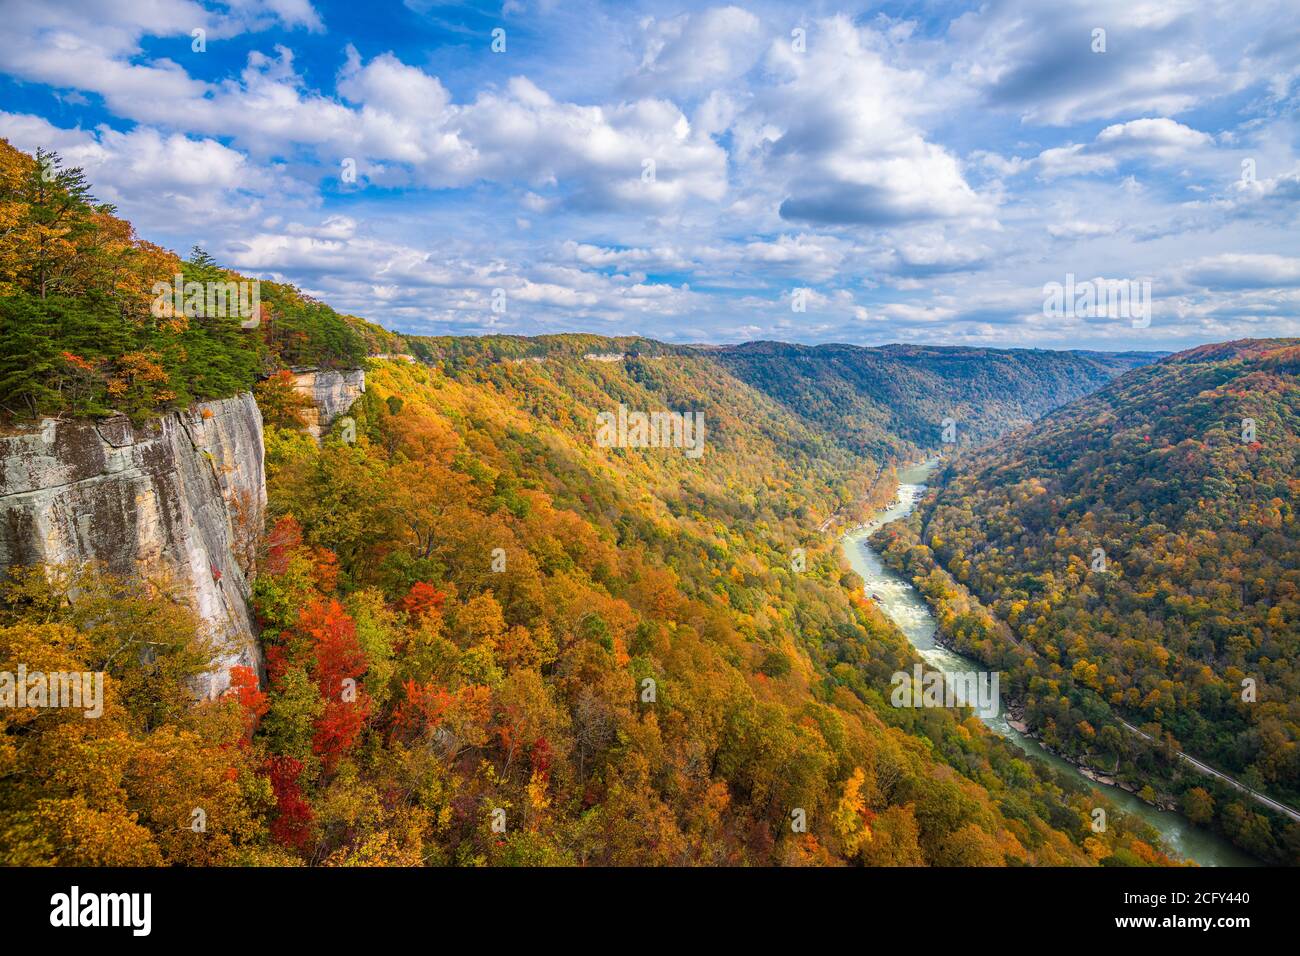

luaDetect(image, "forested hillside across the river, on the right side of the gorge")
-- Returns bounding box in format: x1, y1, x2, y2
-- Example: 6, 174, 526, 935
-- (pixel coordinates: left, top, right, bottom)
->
876, 339, 1300, 861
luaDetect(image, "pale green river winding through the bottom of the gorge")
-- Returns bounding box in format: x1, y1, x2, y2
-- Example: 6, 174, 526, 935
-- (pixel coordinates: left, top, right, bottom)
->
840, 462, 1260, 866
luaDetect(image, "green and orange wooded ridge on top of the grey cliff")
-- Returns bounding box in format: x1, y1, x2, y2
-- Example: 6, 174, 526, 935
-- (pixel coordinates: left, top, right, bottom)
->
0, 139, 377, 420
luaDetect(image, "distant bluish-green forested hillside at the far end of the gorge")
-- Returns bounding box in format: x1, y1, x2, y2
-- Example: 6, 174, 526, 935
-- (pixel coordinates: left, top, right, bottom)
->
709, 342, 1157, 457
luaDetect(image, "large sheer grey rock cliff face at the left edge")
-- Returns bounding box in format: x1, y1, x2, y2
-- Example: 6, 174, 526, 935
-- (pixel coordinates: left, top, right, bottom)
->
0, 392, 266, 696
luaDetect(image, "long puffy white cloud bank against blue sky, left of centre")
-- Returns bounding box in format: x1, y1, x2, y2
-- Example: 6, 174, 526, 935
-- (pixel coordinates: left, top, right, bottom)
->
204, 48, 727, 212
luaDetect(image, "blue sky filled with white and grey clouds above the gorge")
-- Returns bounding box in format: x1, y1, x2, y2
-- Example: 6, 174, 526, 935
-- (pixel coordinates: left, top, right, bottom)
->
0, 0, 1300, 350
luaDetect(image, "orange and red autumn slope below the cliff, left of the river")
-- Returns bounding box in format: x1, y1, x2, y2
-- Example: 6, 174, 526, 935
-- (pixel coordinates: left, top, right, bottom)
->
0, 343, 1190, 865
